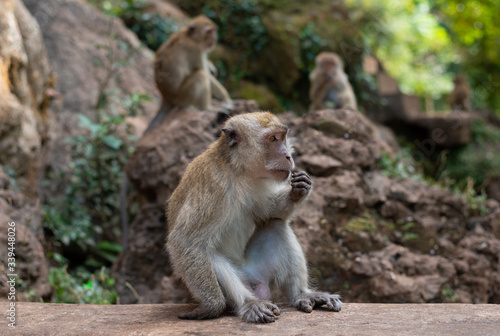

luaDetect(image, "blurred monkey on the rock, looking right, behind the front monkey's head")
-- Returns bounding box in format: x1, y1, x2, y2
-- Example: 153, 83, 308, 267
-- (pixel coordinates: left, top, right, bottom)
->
153, 15, 231, 127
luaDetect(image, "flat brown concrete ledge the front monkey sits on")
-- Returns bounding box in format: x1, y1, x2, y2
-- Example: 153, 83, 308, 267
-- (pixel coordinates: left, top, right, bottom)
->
6, 301, 500, 336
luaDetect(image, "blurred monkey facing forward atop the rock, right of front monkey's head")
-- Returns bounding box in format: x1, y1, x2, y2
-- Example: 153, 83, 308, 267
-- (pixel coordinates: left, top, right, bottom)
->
309, 52, 358, 111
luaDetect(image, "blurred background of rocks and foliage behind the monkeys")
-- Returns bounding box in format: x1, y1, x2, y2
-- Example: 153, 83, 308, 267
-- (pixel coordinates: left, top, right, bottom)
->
0, 0, 500, 304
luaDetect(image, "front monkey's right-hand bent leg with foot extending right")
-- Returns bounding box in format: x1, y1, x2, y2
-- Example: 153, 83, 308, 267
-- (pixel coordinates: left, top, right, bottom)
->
268, 220, 342, 313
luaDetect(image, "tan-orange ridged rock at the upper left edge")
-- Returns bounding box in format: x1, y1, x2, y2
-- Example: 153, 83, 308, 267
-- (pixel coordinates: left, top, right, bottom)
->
0, 0, 51, 176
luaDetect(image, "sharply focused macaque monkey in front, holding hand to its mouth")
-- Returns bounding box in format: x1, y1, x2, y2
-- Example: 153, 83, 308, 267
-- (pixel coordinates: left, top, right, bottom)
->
166, 112, 342, 323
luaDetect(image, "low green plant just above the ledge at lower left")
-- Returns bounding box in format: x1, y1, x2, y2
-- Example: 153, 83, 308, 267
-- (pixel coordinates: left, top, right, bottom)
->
49, 265, 118, 304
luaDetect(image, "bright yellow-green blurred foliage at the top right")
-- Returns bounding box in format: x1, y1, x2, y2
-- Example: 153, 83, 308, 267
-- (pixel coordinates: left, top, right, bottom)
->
346, 0, 454, 99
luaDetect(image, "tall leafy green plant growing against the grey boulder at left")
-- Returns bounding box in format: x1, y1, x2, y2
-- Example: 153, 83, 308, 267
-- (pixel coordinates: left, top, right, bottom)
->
43, 36, 151, 260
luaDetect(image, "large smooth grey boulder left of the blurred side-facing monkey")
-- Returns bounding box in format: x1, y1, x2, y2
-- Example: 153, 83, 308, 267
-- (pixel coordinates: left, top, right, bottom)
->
23, 0, 159, 184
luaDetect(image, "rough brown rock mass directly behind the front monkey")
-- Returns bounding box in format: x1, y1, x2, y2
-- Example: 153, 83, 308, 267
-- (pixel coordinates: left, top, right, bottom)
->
116, 106, 500, 303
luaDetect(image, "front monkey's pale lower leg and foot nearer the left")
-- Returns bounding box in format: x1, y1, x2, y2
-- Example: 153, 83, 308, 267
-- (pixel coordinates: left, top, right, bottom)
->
213, 255, 280, 323
